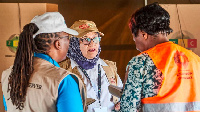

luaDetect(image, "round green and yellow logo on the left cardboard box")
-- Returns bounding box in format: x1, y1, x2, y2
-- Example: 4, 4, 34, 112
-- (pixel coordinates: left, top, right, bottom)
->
6, 34, 19, 53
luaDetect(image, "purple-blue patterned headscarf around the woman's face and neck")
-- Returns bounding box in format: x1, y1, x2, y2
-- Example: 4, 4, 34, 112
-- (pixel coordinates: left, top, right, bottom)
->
67, 37, 101, 70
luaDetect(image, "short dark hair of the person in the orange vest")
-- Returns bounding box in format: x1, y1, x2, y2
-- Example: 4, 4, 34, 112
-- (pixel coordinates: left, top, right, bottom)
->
129, 3, 173, 36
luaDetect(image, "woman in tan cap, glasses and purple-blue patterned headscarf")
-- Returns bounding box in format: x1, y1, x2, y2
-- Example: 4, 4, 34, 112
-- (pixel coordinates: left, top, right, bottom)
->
60, 20, 122, 112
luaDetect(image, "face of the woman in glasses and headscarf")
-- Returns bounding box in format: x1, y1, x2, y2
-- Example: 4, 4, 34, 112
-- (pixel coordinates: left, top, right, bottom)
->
80, 32, 99, 59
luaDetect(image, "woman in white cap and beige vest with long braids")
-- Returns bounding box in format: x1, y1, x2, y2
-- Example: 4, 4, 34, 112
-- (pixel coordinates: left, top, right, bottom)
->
1, 12, 85, 112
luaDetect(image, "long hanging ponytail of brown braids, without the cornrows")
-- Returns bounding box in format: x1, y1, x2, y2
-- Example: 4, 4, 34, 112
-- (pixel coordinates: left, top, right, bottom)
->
8, 23, 38, 110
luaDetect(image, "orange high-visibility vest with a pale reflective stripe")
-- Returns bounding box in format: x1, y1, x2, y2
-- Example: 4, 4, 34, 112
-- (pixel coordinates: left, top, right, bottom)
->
141, 42, 200, 112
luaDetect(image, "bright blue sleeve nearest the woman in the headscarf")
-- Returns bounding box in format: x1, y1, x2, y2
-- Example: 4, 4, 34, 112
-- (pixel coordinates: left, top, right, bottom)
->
56, 75, 83, 112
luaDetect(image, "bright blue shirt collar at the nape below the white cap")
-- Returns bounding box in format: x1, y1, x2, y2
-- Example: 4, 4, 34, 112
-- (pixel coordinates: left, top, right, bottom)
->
34, 52, 60, 67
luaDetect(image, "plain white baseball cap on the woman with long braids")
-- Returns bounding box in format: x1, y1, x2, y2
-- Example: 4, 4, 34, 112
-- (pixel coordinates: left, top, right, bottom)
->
31, 12, 78, 38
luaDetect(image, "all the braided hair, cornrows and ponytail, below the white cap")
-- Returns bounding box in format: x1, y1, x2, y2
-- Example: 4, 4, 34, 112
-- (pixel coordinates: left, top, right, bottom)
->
8, 23, 59, 110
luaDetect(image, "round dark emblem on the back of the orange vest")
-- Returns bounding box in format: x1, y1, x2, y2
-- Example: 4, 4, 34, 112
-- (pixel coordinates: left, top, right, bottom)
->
174, 51, 189, 68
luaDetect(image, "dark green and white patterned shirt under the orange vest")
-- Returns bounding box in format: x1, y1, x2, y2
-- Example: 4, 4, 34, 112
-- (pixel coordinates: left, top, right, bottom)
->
120, 53, 164, 112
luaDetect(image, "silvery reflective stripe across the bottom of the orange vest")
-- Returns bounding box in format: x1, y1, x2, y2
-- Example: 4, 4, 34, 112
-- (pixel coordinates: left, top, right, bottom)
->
142, 102, 200, 112
